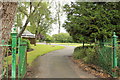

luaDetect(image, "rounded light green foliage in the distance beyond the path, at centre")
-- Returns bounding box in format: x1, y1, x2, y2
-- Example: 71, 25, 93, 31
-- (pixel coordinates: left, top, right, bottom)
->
52, 33, 73, 43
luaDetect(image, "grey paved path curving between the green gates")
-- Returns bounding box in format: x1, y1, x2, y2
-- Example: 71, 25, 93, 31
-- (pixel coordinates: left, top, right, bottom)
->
31, 44, 95, 78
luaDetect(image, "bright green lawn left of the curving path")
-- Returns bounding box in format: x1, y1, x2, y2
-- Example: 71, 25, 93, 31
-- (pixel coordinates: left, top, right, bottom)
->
5, 44, 65, 66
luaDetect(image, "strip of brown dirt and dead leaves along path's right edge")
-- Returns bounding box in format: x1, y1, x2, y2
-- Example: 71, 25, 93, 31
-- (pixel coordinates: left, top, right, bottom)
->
70, 57, 111, 78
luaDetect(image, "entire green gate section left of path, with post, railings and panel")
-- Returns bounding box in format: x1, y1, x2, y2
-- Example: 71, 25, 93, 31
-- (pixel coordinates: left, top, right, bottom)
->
0, 29, 27, 80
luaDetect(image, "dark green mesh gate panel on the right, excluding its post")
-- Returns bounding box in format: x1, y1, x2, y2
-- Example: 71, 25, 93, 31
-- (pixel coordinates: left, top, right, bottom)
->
97, 39, 113, 75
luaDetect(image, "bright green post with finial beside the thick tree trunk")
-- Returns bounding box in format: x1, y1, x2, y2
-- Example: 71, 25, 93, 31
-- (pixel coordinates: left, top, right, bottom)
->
11, 28, 17, 80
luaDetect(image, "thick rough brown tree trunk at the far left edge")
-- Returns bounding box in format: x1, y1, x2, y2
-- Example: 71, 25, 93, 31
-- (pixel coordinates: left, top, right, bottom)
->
0, 2, 17, 79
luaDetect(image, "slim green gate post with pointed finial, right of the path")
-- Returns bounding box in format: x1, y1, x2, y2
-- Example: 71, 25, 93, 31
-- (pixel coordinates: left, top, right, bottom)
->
112, 32, 118, 77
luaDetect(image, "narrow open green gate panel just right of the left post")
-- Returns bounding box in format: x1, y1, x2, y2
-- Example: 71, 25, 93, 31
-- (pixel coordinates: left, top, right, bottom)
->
18, 38, 27, 79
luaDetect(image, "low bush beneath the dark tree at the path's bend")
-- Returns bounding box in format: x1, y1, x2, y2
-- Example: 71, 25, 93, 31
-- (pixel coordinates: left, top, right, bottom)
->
73, 46, 97, 63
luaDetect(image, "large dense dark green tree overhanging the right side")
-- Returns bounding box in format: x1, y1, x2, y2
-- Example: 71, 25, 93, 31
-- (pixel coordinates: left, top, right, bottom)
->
64, 2, 120, 42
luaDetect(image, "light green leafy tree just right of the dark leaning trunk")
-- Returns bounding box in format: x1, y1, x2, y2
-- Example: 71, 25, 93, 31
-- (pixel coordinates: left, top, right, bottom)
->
28, 3, 54, 40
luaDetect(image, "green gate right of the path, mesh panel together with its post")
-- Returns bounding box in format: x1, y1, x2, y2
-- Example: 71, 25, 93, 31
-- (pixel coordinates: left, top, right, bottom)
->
96, 32, 120, 77
